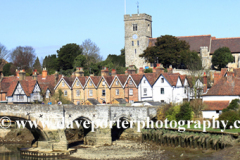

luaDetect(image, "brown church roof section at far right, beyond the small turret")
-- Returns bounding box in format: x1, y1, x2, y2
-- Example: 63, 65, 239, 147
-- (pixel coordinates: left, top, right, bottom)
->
210, 37, 240, 53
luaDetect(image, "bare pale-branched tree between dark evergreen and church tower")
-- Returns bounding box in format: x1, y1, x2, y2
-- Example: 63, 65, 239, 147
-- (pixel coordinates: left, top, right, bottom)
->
81, 39, 103, 66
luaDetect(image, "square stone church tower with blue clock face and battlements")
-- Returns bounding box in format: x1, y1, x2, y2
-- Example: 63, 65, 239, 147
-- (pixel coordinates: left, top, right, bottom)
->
124, 13, 152, 68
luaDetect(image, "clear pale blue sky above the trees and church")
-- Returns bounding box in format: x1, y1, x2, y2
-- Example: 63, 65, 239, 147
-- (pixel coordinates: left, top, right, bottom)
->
0, 0, 240, 59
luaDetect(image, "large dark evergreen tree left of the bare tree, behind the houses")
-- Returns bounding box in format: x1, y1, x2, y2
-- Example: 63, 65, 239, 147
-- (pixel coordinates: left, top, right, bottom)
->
57, 43, 83, 70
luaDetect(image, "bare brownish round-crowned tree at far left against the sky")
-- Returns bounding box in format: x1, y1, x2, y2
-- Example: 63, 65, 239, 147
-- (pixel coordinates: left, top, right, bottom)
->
10, 46, 36, 73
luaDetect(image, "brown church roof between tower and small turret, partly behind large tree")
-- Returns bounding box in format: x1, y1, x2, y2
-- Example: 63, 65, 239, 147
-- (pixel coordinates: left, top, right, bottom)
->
148, 35, 211, 52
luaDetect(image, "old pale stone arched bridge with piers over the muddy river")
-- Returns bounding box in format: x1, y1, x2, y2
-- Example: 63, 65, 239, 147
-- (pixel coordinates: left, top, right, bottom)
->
0, 104, 157, 151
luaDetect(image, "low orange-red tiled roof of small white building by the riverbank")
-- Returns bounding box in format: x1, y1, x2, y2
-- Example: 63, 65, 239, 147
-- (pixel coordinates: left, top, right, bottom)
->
203, 101, 229, 111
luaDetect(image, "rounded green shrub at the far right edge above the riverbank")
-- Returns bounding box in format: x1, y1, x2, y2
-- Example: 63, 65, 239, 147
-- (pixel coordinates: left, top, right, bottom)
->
218, 110, 240, 129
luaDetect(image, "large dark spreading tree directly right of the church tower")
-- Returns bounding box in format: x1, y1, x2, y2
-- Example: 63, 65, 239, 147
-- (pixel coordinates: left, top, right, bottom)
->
140, 35, 190, 68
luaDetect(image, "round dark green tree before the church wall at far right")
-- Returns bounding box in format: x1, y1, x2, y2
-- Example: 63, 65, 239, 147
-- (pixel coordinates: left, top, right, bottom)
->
212, 47, 234, 70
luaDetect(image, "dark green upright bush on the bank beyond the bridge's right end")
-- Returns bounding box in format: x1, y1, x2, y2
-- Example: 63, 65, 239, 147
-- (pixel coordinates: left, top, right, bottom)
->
176, 102, 192, 121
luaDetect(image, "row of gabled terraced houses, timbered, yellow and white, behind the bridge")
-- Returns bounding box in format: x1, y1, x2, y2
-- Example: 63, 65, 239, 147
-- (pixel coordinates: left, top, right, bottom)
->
0, 64, 206, 105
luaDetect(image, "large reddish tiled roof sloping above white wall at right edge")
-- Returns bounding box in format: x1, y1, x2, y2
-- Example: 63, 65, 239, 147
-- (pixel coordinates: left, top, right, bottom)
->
203, 77, 240, 96
